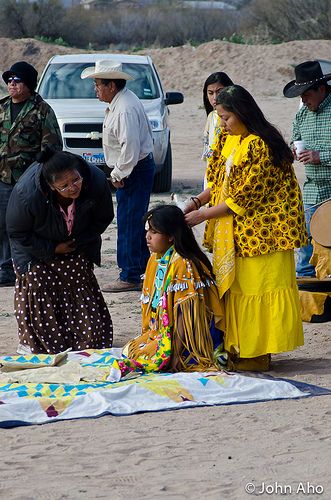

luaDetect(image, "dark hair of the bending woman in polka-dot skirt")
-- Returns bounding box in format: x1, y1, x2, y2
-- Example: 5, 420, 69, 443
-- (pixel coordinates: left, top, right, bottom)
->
37, 146, 82, 185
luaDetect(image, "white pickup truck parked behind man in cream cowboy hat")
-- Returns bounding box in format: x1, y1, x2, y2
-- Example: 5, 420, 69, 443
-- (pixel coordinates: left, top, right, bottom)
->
37, 54, 184, 192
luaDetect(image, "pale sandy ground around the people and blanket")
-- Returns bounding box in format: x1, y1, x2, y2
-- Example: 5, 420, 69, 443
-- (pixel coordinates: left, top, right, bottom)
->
0, 42, 331, 500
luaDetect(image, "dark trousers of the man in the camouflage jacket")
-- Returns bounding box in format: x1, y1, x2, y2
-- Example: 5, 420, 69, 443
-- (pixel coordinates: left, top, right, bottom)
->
0, 181, 15, 282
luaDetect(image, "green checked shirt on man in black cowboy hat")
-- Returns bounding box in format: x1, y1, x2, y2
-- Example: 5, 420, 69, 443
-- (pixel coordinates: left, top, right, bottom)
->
291, 93, 331, 205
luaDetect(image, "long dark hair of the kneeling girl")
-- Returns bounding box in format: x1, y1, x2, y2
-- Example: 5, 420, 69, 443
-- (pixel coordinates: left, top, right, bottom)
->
143, 205, 213, 278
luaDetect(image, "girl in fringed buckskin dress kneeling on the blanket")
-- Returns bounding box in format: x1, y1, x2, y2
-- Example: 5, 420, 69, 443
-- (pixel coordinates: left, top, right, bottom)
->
119, 205, 223, 374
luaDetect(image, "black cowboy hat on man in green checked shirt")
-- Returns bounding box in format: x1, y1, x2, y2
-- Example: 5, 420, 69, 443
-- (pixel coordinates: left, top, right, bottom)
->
283, 61, 331, 97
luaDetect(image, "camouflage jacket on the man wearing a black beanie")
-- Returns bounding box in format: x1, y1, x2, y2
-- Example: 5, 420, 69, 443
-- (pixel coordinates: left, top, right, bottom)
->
0, 94, 62, 184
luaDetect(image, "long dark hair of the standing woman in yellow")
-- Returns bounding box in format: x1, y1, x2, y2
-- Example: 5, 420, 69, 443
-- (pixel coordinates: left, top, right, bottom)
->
216, 85, 294, 166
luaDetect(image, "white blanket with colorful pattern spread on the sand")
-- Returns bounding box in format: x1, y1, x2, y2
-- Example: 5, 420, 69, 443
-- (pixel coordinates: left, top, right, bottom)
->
0, 349, 331, 427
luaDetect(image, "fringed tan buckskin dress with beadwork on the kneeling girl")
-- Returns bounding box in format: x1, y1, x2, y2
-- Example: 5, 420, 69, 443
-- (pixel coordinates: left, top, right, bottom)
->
124, 247, 224, 371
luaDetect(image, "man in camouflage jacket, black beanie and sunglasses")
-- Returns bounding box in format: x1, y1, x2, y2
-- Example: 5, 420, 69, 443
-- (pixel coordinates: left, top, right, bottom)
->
0, 61, 62, 286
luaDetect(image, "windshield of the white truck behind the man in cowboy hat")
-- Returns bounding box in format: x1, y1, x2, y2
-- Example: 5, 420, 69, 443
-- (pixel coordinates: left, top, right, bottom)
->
38, 63, 160, 99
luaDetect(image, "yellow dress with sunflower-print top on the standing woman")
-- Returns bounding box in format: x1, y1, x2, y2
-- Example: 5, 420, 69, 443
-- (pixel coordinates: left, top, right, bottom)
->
205, 134, 306, 358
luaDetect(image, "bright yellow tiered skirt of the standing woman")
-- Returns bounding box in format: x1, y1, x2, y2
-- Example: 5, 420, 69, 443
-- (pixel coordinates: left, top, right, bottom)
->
225, 250, 304, 358
